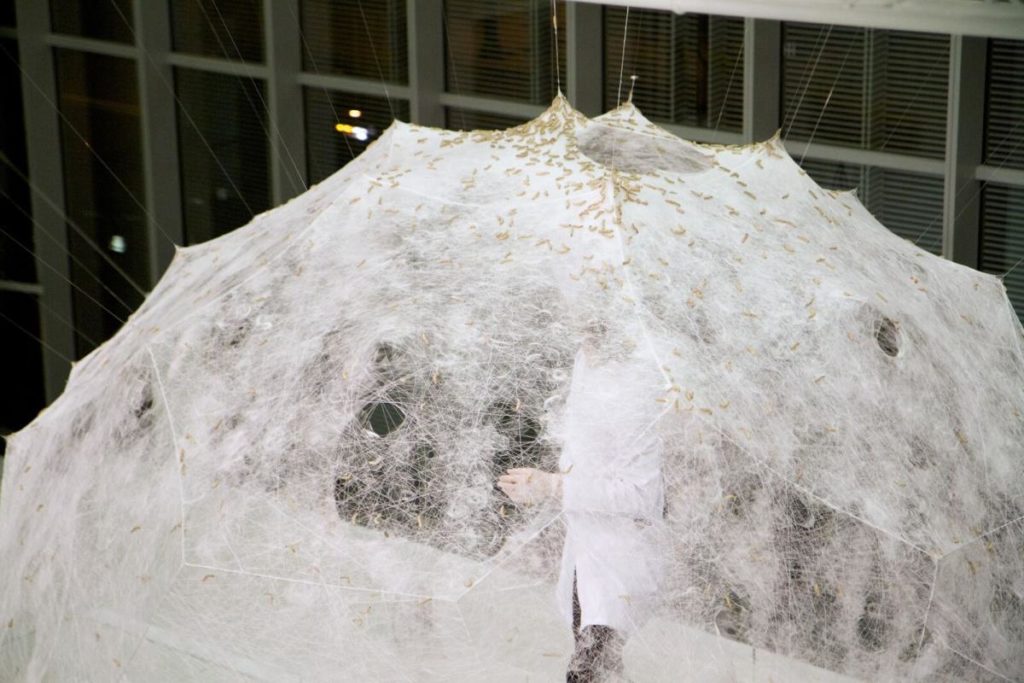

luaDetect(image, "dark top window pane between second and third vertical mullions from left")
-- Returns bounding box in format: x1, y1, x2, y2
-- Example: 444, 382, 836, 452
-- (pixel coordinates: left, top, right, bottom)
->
171, 0, 263, 61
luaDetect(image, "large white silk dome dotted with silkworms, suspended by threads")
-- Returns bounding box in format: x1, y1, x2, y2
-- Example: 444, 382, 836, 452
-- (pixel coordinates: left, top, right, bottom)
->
0, 97, 1024, 681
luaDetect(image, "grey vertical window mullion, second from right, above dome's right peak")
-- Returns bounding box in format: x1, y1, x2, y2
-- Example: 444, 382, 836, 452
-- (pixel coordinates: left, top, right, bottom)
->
742, 18, 782, 142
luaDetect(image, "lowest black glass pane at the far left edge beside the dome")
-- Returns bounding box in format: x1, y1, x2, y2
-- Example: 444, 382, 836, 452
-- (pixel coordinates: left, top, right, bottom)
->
0, 291, 45, 434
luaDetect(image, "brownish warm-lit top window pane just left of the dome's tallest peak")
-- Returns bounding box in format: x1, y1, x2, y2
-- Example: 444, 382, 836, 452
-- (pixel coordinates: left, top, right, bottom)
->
444, 0, 565, 104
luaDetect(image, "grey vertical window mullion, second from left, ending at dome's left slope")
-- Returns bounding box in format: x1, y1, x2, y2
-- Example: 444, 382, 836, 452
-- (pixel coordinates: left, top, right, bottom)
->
132, 0, 184, 286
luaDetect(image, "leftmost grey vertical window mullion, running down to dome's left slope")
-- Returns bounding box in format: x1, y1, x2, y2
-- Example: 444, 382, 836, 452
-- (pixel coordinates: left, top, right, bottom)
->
15, 0, 75, 402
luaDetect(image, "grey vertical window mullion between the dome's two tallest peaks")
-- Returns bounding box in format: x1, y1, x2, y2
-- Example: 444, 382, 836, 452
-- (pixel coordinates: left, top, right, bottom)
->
565, 2, 604, 117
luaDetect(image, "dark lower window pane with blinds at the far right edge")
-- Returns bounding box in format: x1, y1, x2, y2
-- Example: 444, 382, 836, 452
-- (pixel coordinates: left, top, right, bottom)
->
981, 183, 1024, 321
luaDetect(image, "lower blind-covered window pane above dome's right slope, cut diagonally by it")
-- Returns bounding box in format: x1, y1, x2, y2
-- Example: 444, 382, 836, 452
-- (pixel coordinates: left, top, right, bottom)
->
803, 159, 943, 255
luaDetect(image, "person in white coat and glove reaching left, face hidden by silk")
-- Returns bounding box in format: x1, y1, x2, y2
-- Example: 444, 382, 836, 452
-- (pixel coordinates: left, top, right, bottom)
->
498, 327, 665, 682
